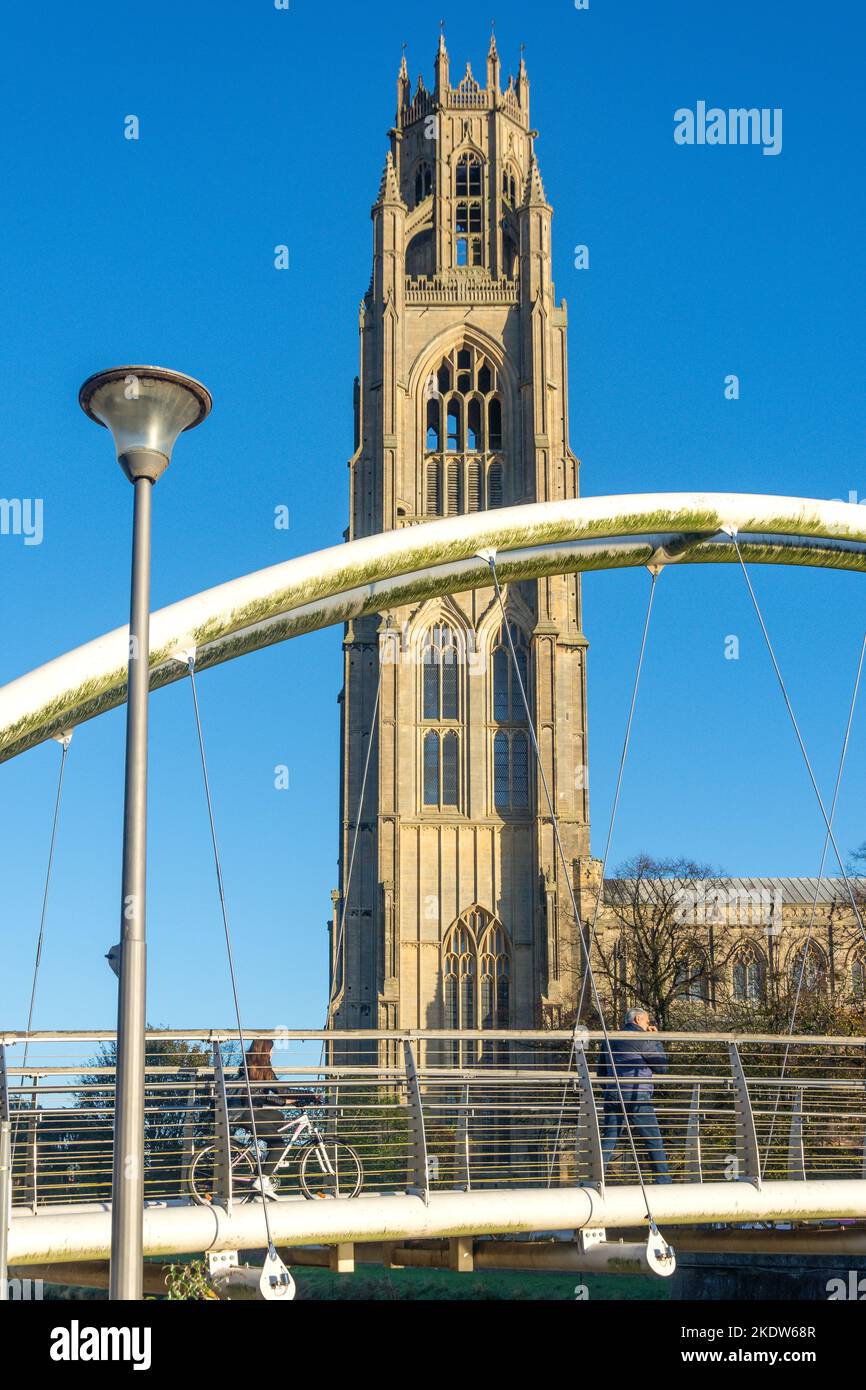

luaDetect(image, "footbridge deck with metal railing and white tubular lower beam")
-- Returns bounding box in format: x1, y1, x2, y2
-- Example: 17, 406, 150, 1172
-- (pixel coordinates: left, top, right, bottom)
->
0, 1029, 866, 1266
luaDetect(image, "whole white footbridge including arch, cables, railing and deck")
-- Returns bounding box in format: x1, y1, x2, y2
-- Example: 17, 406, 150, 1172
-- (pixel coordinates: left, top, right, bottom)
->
0, 493, 866, 1284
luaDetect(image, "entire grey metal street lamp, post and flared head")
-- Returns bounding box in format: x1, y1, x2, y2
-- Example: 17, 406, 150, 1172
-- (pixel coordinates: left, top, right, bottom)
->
79, 367, 211, 1300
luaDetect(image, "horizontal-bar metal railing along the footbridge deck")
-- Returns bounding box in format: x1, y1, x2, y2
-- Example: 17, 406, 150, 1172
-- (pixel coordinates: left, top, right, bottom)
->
0, 1030, 866, 1209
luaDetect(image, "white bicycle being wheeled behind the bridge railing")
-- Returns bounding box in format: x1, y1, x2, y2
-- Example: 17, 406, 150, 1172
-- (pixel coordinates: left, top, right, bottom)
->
189, 1097, 364, 1207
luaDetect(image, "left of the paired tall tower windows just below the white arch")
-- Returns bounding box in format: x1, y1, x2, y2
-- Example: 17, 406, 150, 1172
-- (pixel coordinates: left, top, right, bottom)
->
421, 623, 461, 810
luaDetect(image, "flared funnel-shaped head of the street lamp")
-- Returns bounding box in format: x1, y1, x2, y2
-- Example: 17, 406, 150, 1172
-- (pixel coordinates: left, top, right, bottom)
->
78, 367, 213, 482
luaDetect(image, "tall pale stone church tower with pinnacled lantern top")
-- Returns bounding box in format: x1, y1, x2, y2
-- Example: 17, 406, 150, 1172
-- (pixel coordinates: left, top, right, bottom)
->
329, 38, 589, 1030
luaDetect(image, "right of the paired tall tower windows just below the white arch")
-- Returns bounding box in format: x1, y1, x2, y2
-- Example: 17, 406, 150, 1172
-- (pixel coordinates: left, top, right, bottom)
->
491, 623, 530, 812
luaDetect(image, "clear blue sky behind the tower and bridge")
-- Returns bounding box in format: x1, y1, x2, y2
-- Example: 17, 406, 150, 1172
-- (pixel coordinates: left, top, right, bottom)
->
0, 0, 866, 1027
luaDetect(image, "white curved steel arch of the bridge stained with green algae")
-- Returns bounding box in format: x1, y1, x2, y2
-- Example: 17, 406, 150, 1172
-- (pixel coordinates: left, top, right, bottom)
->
0, 492, 866, 762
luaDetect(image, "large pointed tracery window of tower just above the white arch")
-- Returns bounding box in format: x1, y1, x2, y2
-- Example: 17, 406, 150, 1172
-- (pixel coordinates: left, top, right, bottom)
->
421, 343, 506, 516
